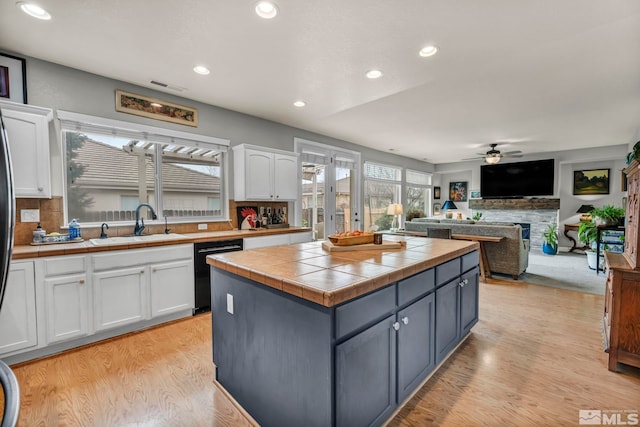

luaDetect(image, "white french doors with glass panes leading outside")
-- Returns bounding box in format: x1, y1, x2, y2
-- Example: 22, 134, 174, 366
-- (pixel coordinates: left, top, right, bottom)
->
295, 138, 362, 240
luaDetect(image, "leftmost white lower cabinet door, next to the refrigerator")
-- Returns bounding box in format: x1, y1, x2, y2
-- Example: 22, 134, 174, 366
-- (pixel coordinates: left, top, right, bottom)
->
0, 261, 38, 354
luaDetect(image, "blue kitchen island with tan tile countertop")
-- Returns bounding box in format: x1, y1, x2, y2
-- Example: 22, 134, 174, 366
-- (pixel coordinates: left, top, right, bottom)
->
207, 236, 479, 427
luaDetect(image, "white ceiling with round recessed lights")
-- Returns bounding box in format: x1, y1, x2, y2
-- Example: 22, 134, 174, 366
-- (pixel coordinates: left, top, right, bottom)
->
0, 0, 640, 163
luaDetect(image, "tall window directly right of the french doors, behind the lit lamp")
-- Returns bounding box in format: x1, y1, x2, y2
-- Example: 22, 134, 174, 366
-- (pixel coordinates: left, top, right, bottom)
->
364, 162, 402, 230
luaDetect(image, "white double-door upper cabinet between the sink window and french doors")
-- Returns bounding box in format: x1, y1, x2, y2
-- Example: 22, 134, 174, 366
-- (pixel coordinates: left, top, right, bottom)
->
233, 144, 298, 201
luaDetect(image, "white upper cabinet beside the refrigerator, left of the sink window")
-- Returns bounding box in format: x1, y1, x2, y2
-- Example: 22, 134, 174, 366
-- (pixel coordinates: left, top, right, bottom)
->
0, 101, 53, 198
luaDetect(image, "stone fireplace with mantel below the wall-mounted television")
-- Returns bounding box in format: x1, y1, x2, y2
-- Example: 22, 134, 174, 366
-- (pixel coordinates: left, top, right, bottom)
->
469, 199, 560, 252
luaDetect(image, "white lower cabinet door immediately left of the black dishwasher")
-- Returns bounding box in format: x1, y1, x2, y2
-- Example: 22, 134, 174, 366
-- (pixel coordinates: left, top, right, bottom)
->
150, 260, 195, 317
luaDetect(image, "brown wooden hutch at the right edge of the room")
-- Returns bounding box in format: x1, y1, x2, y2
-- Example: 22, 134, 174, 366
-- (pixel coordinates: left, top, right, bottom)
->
603, 159, 640, 371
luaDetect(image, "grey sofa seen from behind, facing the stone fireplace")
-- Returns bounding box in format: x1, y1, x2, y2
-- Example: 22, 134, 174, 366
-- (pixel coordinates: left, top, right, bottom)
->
405, 218, 530, 280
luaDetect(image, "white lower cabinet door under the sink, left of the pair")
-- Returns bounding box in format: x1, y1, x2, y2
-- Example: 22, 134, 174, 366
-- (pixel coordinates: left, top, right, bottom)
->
92, 266, 147, 331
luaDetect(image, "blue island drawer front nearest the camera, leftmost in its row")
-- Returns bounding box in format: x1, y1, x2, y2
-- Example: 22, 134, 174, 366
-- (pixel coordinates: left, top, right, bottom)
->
336, 284, 396, 339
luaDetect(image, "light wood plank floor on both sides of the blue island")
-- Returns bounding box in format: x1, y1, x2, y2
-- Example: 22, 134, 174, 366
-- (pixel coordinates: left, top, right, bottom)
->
5, 280, 640, 426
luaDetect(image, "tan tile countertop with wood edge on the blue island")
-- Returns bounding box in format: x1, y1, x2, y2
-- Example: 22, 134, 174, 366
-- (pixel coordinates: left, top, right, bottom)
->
207, 236, 479, 307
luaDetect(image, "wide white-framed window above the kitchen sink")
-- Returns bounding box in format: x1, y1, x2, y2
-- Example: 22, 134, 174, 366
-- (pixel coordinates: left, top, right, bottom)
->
58, 111, 228, 229
